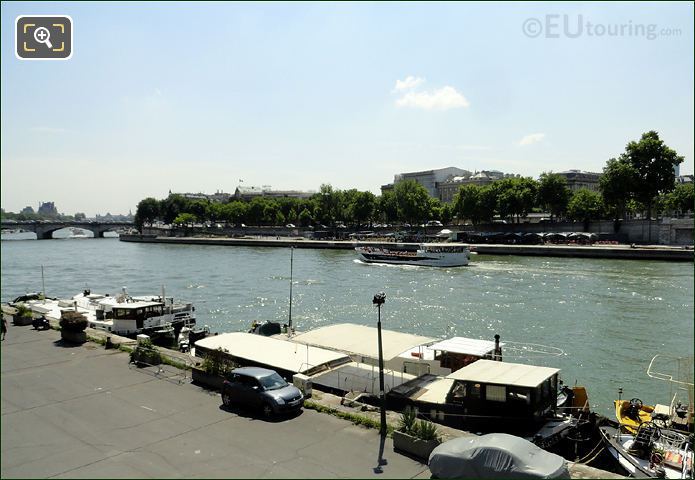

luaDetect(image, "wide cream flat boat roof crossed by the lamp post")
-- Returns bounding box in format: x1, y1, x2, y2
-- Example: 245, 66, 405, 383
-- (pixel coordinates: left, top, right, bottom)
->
291, 323, 436, 360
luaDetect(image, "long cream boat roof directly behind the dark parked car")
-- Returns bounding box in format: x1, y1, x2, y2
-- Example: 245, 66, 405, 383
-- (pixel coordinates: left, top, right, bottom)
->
195, 332, 350, 373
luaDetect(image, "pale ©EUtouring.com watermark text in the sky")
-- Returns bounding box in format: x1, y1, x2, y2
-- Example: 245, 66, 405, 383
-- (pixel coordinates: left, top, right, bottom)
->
521, 14, 682, 40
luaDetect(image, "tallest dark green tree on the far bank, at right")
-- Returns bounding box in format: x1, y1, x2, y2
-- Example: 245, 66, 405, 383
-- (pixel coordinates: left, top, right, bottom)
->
621, 130, 683, 218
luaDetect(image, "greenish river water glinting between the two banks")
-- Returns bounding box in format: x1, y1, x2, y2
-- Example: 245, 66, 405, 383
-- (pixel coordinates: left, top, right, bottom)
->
1, 238, 694, 415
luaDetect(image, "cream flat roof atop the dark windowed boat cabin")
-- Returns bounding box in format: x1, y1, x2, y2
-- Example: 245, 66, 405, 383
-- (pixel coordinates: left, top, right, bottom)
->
446, 360, 560, 388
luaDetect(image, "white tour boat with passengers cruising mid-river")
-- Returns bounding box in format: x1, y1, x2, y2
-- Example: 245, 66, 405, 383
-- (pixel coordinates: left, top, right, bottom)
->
355, 243, 471, 267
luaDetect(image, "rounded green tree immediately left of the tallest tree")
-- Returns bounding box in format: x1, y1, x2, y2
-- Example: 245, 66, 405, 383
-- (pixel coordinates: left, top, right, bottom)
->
599, 156, 638, 220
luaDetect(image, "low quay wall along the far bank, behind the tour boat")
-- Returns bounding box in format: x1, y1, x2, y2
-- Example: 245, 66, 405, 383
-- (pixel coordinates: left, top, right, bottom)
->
119, 235, 695, 262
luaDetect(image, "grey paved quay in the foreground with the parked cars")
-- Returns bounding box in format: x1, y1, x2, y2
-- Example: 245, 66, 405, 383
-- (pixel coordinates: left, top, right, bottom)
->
0, 325, 623, 479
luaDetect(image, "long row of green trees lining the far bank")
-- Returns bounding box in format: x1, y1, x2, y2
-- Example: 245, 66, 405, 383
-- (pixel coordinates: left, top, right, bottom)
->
135, 131, 693, 228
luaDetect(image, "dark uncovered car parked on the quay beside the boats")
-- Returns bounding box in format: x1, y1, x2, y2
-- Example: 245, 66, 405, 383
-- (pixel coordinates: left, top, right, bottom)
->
222, 367, 304, 417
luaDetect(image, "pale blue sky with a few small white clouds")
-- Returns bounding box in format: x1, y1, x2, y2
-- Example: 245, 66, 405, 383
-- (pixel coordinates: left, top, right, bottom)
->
0, 2, 695, 216
